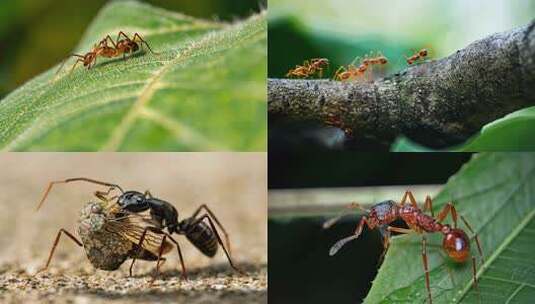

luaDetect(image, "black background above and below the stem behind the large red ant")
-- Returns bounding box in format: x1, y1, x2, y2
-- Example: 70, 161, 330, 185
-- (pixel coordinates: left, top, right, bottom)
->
268, 152, 471, 304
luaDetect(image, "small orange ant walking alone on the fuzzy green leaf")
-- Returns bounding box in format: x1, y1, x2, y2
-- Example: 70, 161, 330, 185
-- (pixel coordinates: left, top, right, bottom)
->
56, 31, 160, 74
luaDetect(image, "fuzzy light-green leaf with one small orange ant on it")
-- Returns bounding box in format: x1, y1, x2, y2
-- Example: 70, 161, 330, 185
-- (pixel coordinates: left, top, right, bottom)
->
0, 1, 267, 151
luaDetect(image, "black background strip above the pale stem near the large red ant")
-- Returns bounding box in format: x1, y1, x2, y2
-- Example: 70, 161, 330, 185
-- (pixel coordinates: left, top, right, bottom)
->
268, 151, 471, 189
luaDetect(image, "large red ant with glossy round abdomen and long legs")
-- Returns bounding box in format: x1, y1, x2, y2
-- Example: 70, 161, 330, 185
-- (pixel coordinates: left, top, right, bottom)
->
323, 191, 484, 303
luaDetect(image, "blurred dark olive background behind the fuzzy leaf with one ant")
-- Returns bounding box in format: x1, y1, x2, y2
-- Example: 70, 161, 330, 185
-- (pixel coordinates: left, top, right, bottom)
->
0, 0, 266, 98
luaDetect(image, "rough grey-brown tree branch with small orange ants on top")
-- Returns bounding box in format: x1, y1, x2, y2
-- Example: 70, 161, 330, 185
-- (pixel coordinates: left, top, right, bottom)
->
268, 20, 535, 147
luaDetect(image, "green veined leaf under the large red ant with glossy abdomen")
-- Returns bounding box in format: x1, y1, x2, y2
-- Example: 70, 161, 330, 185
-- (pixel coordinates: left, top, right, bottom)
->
365, 153, 535, 303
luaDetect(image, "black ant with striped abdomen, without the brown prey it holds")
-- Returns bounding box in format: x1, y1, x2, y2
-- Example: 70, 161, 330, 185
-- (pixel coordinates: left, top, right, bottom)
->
37, 177, 243, 277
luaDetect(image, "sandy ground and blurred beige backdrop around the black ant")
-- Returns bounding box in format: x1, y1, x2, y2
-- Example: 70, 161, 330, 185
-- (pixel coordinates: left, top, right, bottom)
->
0, 153, 267, 303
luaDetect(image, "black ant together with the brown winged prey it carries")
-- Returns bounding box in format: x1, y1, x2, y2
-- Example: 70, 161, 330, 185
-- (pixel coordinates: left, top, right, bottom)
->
37, 177, 243, 277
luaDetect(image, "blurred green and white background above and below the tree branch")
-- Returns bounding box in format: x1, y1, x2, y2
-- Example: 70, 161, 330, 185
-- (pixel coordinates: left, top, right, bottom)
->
268, 0, 535, 151
